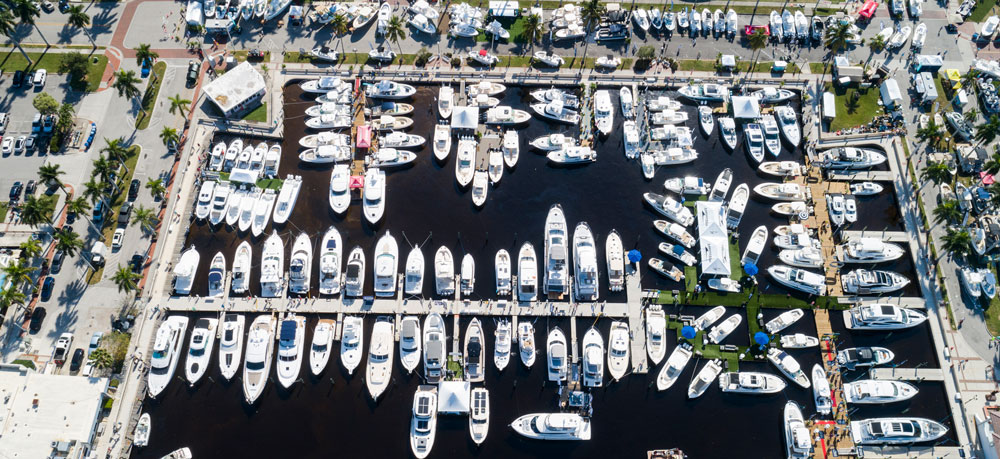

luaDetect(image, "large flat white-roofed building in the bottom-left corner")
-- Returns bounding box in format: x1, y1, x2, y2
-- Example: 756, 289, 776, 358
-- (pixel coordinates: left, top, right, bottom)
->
0, 365, 108, 458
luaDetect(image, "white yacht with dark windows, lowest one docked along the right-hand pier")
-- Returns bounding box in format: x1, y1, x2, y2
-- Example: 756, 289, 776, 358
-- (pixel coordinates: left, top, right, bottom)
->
850, 417, 948, 445
